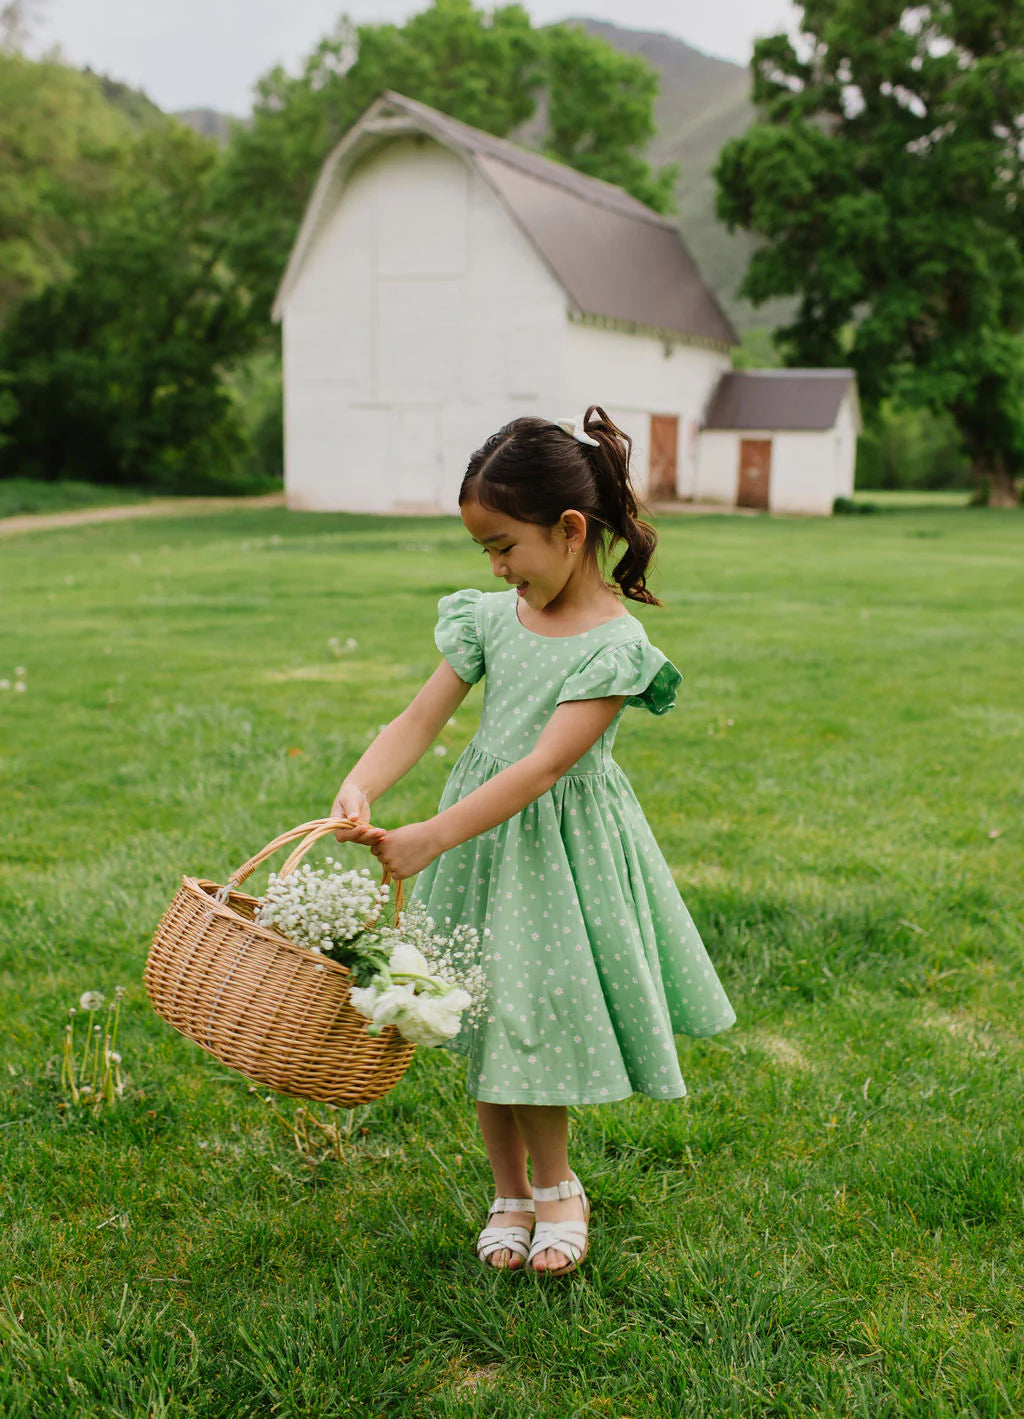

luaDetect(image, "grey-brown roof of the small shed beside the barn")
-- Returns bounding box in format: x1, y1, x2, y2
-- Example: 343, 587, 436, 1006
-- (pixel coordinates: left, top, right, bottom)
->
703, 369, 859, 430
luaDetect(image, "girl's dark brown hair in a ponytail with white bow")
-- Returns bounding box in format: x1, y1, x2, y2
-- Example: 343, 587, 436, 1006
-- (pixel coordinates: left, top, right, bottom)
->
458, 404, 661, 606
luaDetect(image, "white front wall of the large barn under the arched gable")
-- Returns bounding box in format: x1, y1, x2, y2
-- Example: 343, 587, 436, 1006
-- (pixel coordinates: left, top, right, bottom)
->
284, 138, 566, 512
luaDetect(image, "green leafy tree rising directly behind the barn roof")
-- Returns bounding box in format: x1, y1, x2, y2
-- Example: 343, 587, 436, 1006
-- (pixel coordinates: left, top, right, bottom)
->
218, 0, 674, 322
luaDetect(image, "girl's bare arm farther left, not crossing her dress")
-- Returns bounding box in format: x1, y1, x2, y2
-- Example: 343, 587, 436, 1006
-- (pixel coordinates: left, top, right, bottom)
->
330, 660, 472, 843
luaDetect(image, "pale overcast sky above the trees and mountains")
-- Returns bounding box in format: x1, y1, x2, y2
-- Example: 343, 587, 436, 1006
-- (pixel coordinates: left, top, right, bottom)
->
33, 0, 793, 115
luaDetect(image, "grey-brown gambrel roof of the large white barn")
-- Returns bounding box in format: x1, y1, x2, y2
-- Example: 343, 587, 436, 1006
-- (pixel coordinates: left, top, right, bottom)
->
274, 89, 738, 345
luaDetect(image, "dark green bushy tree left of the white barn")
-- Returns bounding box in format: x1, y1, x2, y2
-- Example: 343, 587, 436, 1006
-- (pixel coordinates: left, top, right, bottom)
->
0, 122, 258, 490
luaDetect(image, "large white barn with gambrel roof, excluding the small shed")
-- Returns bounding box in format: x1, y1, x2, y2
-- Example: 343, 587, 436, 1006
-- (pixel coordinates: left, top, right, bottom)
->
274, 92, 736, 512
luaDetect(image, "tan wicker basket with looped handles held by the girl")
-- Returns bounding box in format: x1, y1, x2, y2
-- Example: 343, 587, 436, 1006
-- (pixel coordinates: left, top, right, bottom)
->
145, 819, 416, 1108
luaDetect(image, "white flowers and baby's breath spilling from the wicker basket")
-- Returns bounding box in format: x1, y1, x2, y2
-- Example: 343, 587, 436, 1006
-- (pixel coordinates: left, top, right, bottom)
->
257, 857, 486, 1046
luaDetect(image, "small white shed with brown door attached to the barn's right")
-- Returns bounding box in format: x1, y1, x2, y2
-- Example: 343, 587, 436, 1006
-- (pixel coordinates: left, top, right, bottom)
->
694, 369, 861, 514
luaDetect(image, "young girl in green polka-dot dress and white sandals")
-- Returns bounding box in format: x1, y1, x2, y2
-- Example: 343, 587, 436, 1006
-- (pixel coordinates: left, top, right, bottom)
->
332, 406, 736, 1276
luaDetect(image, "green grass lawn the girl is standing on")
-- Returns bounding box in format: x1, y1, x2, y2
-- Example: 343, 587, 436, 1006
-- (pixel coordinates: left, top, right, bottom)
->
0, 509, 1024, 1419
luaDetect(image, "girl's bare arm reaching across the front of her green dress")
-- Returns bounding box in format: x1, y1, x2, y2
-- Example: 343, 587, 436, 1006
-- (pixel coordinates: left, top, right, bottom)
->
363, 695, 625, 877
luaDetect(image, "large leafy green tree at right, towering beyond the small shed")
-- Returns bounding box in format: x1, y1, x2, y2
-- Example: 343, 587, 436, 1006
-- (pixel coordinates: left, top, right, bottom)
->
716, 0, 1024, 505
